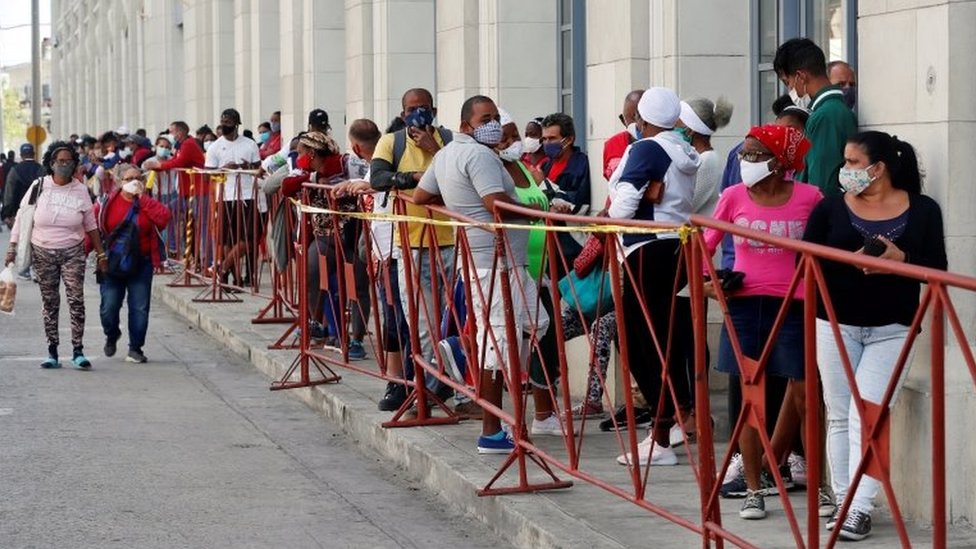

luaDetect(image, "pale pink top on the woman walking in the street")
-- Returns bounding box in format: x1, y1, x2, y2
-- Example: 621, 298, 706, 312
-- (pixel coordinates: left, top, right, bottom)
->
10, 176, 98, 250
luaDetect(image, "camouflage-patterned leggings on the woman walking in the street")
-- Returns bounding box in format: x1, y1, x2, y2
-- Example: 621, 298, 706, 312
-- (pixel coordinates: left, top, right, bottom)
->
32, 244, 85, 349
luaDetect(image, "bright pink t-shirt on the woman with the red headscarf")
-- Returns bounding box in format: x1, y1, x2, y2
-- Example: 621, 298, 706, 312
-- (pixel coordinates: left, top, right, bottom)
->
705, 181, 823, 299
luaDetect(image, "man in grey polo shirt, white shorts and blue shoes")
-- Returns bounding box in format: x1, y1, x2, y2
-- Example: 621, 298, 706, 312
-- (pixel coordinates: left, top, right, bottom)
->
414, 95, 548, 454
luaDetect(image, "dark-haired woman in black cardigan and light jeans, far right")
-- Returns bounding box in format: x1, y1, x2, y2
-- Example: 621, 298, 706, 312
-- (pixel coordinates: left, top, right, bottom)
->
803, 131, 948, 541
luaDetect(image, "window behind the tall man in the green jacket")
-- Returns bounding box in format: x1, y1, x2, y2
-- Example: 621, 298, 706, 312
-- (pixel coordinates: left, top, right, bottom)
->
751, 0, 857, 124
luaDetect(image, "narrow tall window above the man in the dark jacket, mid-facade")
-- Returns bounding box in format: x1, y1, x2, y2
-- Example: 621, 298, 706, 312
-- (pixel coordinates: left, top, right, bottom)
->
559, 0, 586, 149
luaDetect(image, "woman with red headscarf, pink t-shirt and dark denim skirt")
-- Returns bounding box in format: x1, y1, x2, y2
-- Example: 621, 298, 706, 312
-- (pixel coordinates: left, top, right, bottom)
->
705, 125, 823, 519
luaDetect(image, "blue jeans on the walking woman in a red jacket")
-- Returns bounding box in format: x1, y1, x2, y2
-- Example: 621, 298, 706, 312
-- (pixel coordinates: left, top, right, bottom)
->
98, 257, 153, 352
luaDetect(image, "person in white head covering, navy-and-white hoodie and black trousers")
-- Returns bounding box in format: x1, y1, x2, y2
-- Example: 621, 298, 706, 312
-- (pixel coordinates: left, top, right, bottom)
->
605, 88, 701, 466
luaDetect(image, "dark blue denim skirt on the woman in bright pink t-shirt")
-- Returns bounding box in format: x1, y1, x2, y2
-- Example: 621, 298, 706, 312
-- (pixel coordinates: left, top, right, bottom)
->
716, 296, 804, 380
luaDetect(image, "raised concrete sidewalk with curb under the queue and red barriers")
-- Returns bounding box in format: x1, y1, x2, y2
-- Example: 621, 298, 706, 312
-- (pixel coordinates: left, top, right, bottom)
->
154, 277, 976, 548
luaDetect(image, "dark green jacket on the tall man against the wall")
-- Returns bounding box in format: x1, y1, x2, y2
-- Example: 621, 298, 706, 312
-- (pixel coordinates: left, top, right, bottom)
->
796, 86, 857, 196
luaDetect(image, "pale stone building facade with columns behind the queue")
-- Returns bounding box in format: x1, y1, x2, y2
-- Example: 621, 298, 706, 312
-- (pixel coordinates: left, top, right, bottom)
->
52, 0, 976, 521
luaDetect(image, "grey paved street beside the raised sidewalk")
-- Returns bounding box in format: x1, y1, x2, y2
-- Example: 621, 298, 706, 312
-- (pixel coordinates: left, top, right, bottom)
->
0, 231, 506, 549
